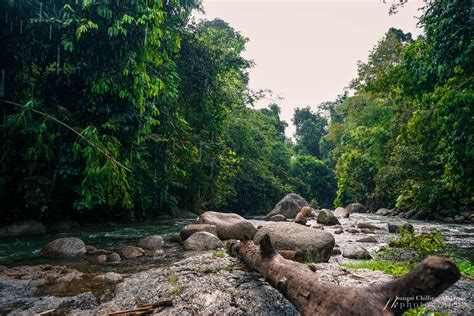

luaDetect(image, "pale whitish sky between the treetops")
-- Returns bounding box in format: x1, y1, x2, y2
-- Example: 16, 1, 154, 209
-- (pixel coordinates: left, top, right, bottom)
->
198, 0, 423, 137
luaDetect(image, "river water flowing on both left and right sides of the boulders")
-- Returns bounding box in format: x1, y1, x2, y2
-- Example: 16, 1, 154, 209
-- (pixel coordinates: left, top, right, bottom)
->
0, 214, 474, 273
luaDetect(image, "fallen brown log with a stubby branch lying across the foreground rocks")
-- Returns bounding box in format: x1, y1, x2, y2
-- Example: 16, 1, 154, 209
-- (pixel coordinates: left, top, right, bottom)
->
227, 235, 460, 315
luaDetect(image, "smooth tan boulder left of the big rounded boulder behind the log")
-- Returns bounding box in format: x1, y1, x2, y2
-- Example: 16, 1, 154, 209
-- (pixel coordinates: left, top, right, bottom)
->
197, 211, 257, 240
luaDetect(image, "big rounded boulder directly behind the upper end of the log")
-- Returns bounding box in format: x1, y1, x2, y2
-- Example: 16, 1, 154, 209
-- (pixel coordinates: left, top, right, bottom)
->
254, 222, 335, 262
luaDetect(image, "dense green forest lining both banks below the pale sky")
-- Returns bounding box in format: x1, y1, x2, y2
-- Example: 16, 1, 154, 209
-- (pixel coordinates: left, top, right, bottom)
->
0, 0, 474, 221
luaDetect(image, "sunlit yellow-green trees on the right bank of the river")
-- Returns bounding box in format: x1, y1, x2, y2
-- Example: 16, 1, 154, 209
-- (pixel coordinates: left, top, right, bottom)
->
317, 0, 474, 217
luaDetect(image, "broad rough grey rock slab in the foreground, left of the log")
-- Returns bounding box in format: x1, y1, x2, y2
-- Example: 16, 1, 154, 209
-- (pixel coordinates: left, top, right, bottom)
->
93, 254, 299, 316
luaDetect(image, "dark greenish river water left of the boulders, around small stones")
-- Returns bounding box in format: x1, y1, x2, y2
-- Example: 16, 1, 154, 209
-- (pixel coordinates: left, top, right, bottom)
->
0, 218, 194, 273
